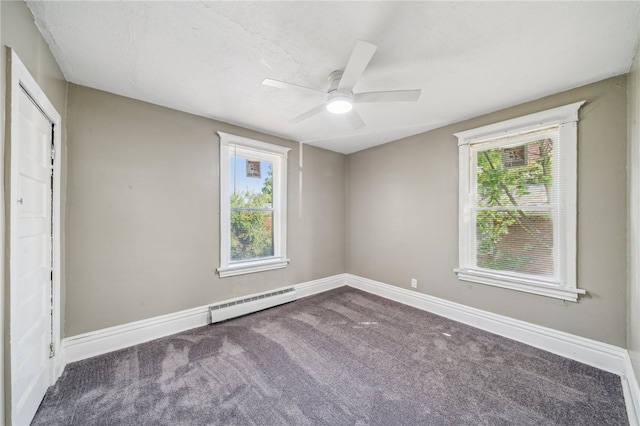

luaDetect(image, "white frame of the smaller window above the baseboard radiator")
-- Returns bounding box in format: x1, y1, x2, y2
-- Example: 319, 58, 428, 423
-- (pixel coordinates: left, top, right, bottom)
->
217, 132, 290, 278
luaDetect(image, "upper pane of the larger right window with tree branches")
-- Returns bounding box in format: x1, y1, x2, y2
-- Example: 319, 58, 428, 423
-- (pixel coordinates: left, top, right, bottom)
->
476, 138, 553, 207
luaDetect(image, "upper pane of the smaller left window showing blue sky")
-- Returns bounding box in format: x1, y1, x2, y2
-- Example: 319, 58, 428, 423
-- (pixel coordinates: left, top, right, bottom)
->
229, 156, 273, 208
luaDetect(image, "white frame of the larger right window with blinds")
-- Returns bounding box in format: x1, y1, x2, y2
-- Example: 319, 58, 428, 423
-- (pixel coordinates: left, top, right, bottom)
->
454, 101, 585, 302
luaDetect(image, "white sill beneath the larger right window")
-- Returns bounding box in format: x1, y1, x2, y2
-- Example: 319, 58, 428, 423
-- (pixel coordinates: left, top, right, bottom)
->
454, 268, 586, 302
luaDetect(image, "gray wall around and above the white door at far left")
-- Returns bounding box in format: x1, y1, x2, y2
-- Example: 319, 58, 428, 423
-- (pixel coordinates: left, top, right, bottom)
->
0, 1, 67, 423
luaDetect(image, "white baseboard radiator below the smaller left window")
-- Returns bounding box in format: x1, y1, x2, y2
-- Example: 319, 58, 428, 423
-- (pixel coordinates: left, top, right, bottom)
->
209, 287, 298, 324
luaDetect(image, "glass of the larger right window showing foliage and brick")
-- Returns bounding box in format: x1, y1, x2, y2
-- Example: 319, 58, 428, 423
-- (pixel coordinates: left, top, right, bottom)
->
475, 138, 553, 275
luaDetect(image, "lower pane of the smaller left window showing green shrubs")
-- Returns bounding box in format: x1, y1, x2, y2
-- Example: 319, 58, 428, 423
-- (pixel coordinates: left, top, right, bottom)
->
231, 208, 273, 262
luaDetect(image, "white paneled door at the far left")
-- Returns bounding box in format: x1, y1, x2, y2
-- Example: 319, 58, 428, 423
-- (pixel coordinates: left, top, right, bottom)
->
10, 88, 53, 425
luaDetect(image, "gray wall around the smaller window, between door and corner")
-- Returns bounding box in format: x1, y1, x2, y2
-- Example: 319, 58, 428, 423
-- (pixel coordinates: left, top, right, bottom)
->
65, 84, 346, 336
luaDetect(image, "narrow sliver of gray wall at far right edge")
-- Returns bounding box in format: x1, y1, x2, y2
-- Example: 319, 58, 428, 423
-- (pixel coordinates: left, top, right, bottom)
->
627, 44, 640, 382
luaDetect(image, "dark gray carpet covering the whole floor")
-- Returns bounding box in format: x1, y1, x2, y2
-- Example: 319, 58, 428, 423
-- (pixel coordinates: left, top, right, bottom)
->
33, 287, 628, 426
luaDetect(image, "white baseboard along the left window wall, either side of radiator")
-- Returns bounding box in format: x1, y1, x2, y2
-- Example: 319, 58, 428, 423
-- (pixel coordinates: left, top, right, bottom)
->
56, 274, 346, 364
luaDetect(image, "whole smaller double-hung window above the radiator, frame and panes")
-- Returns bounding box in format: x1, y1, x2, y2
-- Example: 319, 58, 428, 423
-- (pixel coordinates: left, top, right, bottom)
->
218, 132, 289, 277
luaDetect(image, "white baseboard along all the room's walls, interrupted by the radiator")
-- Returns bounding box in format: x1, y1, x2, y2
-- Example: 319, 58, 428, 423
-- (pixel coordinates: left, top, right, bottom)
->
56, 274, 640, 425
